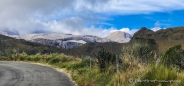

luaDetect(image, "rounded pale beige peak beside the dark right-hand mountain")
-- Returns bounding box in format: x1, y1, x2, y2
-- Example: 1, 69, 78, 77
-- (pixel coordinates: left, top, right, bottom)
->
105, 31, 132, 43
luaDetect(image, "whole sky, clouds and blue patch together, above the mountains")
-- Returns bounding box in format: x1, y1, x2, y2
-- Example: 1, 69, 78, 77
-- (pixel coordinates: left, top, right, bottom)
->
0, 0, 184, 37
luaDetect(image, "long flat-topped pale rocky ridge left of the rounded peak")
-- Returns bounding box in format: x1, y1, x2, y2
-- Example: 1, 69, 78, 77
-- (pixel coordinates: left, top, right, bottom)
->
22, 34, 112, 49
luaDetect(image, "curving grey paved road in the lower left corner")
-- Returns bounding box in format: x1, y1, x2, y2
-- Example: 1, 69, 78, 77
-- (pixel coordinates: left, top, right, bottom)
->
0, 61, 74, 86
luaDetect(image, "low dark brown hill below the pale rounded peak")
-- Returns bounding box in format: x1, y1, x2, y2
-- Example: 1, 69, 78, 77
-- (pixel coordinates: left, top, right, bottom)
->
66, 42, 126, 56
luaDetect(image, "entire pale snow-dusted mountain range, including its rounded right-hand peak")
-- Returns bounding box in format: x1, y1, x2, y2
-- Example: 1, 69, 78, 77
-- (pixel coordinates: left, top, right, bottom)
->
0, 30, 132, 49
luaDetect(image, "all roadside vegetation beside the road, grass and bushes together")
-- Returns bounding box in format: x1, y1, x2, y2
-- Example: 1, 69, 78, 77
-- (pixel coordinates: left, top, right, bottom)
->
0, 43, 184, 86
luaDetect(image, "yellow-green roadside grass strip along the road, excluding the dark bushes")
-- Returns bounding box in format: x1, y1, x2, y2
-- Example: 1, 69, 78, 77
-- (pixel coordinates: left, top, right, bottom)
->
0, 53, 184, 86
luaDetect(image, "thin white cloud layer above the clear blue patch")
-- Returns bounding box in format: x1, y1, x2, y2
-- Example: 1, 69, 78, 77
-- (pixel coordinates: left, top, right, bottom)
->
76, 0, 184, 15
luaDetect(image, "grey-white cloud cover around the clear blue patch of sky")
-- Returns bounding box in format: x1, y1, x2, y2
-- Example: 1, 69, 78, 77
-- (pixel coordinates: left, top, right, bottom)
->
0, 0, 184, 37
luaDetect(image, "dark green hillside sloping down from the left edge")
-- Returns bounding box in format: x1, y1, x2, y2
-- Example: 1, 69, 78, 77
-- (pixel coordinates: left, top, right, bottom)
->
0, 35, 63, 56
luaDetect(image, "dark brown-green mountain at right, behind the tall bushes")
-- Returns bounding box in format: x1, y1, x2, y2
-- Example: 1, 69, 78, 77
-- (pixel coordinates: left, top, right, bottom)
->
133, 27, 184, 53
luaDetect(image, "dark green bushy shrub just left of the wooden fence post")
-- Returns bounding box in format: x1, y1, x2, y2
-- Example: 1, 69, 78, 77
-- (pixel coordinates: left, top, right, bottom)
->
94, 49, 116, 72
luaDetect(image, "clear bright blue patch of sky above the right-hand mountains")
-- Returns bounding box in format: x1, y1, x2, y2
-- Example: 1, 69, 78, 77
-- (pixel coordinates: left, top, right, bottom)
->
102, 10, 184, 29
